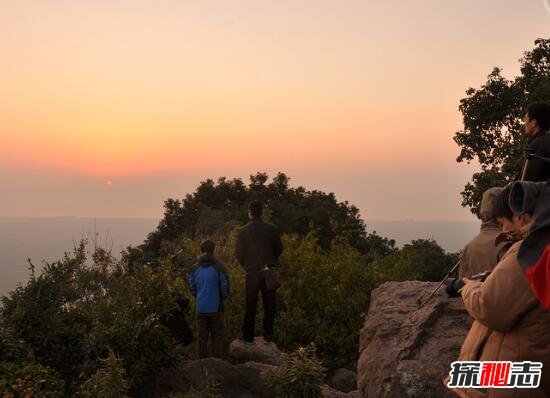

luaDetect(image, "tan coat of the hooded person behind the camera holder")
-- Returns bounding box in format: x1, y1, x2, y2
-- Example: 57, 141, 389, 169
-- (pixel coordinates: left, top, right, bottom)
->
458, 221, 503, 279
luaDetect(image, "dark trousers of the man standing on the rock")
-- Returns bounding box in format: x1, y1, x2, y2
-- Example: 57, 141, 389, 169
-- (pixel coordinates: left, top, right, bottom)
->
243, 272, 277, 341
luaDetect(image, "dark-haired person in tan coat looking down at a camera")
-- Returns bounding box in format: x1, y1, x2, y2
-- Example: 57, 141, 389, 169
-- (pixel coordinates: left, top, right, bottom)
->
452, 182, 550, 398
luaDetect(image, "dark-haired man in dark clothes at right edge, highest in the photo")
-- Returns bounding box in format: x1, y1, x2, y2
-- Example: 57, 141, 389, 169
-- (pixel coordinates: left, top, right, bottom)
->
522, 102, 550, 182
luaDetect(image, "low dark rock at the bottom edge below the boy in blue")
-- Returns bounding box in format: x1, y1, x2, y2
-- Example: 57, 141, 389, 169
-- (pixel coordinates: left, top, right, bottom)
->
155, 358, 256, 398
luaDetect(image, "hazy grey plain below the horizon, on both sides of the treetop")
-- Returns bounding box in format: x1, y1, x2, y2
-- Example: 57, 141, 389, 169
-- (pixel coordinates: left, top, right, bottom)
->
0, 217, 479, 296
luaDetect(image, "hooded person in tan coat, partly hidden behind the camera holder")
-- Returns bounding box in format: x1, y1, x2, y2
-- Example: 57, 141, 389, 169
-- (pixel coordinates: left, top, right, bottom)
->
458, 188, 503, 279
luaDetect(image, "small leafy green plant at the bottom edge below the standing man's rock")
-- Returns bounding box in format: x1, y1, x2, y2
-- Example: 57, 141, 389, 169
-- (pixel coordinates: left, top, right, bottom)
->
270, 344, 325, 398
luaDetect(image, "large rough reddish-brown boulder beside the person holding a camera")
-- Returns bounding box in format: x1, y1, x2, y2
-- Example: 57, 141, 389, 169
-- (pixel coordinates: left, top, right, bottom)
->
357, 281, 472, 398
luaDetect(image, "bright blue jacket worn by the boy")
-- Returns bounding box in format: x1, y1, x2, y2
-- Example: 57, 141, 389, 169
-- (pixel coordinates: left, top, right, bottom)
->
187, 254, 229, 314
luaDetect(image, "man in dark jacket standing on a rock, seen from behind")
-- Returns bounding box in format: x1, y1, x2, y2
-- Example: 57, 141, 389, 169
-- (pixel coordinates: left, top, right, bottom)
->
235, 201, 283, 343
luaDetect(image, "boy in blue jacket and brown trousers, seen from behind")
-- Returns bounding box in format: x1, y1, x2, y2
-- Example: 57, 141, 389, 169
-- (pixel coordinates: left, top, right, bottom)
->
187, 240, 229, 358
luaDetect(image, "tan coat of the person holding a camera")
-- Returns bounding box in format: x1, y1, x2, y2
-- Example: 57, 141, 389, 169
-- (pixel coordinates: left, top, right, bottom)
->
453, 241, 550, 398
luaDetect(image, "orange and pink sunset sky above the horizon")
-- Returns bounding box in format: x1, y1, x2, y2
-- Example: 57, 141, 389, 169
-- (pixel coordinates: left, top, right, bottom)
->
0, 0, 550, 222
